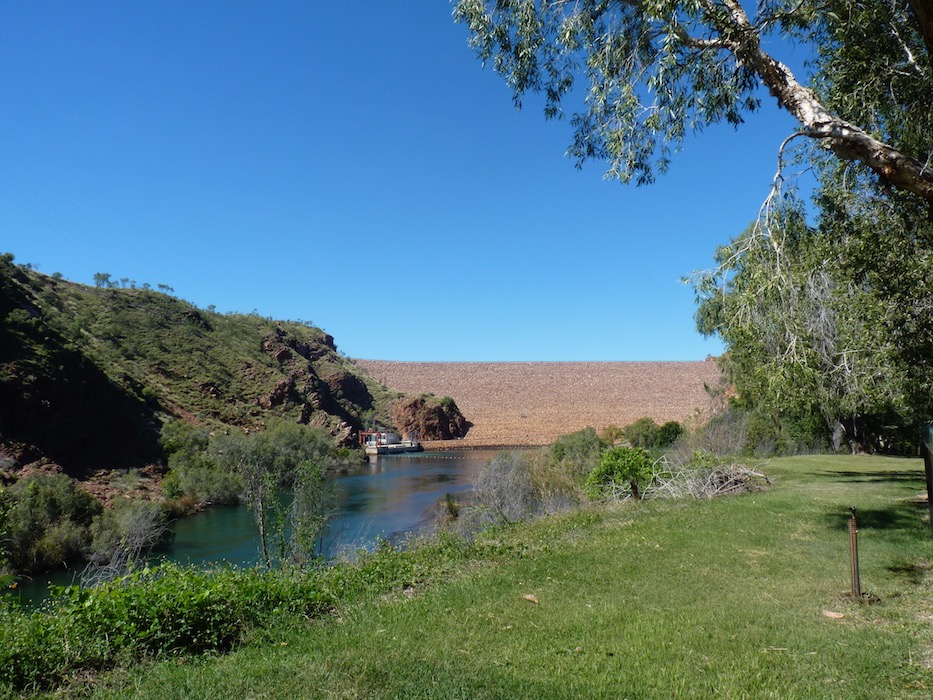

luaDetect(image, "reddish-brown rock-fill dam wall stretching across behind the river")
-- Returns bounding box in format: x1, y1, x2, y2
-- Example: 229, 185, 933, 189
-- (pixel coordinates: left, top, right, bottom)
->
356, 360, 719, 447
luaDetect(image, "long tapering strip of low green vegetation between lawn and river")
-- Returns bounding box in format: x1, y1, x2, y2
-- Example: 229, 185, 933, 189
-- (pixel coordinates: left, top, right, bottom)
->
0, 537, 480, 697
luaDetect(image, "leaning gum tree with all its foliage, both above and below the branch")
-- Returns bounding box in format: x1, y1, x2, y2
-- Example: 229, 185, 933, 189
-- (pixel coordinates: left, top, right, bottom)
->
454, 0, 933, 449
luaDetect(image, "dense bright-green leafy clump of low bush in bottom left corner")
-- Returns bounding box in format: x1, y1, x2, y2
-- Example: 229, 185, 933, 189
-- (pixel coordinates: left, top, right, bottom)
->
0, 564, 333, 691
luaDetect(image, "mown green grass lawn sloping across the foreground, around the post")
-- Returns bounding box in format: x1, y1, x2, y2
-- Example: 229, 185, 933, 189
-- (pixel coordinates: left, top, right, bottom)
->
85, 456, 933, 700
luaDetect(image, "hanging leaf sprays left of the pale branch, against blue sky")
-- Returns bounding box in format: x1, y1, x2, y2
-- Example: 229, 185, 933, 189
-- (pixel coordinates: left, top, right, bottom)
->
454, 0, 758, 184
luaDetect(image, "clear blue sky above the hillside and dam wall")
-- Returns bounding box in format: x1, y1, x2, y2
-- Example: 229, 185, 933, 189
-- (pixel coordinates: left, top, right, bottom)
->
0, 0, 794, 361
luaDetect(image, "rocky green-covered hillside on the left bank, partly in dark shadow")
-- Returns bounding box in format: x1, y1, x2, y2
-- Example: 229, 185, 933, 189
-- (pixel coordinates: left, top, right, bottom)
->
0, 255, 469, 477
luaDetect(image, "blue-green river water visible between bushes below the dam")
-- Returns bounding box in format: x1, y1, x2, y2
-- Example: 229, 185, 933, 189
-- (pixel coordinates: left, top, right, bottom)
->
7, 450, 495, 601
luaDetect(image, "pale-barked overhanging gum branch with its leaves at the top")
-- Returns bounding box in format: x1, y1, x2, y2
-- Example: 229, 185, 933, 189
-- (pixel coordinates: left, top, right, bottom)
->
454, 0, 933, 205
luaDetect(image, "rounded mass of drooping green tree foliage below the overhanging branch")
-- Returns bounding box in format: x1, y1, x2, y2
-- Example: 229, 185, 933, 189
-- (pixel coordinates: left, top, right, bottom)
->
696, 187, 933, 449
